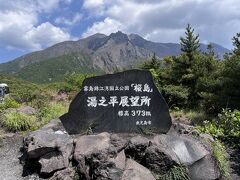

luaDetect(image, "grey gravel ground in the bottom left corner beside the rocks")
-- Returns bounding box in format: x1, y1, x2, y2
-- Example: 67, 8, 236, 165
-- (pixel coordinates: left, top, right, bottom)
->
0, 135, 39, 180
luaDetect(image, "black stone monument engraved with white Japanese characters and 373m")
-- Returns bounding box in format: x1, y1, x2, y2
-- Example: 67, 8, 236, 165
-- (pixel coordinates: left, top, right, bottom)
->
60, 70, 172, 134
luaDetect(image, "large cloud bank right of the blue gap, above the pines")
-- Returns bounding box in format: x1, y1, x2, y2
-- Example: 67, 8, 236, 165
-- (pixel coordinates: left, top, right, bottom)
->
84, 0, 240, 47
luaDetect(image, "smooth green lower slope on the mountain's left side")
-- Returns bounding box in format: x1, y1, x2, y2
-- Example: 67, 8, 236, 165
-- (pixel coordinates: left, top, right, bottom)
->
17, 53, 103, 83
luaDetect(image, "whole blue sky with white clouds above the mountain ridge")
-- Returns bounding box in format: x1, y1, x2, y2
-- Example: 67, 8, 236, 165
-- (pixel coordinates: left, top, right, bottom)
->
0, 0, 240, 63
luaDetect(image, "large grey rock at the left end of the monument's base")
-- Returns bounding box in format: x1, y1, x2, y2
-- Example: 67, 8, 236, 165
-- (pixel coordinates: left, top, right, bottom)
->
24, 120, 73, 175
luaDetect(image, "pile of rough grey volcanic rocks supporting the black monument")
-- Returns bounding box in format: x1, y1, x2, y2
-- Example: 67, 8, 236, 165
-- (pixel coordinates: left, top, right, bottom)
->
22, 120, 221, 180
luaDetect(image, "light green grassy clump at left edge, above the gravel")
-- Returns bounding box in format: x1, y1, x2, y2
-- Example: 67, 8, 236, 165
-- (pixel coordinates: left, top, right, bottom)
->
1, 112, 37, 132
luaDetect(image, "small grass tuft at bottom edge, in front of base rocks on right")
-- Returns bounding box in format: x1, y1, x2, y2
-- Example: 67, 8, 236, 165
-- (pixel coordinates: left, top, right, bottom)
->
157, 165, 190, 180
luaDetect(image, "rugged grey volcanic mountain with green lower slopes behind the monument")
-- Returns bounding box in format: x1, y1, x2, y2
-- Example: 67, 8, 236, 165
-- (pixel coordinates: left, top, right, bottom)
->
0, 31, 229, 82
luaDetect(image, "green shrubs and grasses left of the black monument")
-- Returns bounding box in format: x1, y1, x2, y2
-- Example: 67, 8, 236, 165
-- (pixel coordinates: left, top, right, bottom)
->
0, 70, 98, 132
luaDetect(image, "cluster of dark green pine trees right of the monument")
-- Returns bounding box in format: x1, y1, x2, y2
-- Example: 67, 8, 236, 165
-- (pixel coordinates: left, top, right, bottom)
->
141, 25, 240, 114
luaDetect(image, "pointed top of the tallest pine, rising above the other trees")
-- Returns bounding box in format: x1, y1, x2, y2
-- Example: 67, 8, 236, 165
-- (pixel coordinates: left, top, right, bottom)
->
180, 24, 200, 61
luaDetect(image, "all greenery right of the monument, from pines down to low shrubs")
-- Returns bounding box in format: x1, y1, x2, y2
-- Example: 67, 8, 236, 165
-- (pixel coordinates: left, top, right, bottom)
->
141, 25, 240, 179
